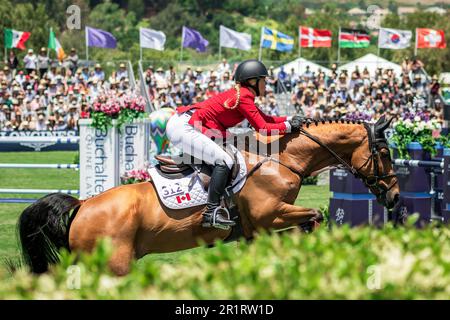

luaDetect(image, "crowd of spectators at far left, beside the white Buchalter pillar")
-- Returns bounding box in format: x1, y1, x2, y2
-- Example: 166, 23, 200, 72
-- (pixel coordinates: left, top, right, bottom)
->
0, 48, 130, 131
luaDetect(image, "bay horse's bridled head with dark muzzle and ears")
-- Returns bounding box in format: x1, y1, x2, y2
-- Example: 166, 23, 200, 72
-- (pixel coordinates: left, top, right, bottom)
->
352, 116, 400, 209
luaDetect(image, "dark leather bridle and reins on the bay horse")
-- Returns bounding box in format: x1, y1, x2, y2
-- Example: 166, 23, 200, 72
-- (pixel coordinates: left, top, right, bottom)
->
300, 123, 397, 201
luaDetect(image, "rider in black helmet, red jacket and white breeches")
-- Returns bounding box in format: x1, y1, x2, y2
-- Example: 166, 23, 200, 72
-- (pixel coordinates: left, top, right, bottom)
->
166, 60, 301, 229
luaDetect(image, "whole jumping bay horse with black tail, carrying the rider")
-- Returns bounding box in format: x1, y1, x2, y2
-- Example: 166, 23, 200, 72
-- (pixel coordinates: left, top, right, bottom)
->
18, 117, 399, 275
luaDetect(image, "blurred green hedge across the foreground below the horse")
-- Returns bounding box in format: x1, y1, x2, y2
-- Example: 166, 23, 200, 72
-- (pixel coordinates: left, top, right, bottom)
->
0, 216, 450, 299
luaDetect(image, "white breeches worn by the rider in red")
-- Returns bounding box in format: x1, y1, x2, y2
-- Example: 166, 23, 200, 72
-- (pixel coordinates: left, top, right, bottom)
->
166, 113, 233, 169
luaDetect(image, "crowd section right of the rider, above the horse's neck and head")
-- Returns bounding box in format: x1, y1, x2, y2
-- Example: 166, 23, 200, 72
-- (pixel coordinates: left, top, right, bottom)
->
285, 58, 443, 120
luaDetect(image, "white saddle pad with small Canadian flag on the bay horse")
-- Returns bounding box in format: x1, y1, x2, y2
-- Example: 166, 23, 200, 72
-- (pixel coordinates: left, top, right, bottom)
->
148, 145, 247, 209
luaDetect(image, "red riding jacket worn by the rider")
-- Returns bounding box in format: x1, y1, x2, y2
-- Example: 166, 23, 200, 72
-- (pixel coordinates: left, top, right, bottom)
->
177, 87, 287, 137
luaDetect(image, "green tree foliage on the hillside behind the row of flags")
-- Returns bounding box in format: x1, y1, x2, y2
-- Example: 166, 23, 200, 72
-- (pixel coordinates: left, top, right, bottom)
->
0, 0, 450, 73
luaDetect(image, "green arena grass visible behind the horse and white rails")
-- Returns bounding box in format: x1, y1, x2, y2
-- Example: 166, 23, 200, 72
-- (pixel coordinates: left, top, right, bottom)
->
0, 151, 330, 268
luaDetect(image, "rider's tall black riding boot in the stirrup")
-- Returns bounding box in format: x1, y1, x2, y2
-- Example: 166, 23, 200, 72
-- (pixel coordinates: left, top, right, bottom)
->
202, 164, 236, 229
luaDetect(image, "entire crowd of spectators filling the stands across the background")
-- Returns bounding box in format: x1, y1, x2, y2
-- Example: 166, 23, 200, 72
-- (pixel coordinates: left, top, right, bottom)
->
0, 53, 443, 131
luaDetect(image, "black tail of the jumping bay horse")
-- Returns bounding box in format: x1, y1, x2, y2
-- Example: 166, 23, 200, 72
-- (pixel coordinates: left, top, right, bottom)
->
18, 193, 81, 273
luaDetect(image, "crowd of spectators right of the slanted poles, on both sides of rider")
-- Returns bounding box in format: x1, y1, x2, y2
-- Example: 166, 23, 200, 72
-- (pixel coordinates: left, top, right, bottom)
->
145, 59, 443, 125
